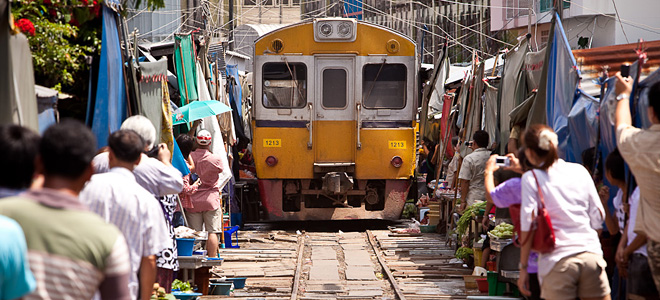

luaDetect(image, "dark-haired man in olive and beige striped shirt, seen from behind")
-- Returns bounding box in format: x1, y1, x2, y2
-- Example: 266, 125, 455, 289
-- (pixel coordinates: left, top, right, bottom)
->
0, 120, 130, 300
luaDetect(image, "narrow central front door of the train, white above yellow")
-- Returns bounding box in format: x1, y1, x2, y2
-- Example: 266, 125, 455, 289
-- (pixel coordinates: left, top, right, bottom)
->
313, 56, 356, 166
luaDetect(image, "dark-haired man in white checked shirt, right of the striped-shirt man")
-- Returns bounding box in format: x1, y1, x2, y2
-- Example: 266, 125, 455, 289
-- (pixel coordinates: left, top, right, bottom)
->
80, 130, 172, 300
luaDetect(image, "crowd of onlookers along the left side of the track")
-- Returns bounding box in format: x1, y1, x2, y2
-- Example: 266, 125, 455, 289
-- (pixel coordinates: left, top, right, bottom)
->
0, 116, 226, 300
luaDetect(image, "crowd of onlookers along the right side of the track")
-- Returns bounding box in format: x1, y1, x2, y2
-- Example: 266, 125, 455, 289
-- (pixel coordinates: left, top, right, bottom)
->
425, 74, 660, 299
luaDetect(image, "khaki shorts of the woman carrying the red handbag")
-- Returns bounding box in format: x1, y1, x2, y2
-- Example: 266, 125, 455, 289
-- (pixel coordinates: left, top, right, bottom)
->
541, 252, 610, 299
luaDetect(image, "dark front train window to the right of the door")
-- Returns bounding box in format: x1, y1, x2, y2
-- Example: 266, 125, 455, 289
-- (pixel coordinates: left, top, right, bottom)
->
362, 64, 407, 109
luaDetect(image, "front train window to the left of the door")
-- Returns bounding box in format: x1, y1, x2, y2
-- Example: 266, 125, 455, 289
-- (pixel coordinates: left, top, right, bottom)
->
262, 62, 307, 108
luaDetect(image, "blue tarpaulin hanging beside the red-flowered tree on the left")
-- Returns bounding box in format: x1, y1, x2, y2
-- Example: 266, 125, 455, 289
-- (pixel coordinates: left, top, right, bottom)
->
92, 5, 127, 148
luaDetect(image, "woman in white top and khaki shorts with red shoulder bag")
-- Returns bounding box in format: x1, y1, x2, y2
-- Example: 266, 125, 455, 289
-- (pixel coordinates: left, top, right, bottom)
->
518, 124, 610, 300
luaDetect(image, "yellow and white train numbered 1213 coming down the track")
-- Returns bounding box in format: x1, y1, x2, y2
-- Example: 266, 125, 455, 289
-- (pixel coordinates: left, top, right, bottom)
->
252, 18, 419, 220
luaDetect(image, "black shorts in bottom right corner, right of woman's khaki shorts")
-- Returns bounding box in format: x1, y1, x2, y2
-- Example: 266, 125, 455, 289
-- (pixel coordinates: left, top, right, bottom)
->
626, 253, 658, 299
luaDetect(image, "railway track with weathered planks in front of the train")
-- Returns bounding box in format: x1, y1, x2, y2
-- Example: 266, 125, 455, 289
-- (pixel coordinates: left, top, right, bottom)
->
201, 230, 470, 300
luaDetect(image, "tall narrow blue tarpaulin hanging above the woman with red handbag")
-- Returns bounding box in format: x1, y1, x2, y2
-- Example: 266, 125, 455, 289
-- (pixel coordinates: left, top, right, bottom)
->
545, 16, 579, 158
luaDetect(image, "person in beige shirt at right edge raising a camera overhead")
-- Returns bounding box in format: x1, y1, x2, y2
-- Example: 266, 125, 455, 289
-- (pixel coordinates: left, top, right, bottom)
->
615, 73, 660, 290
